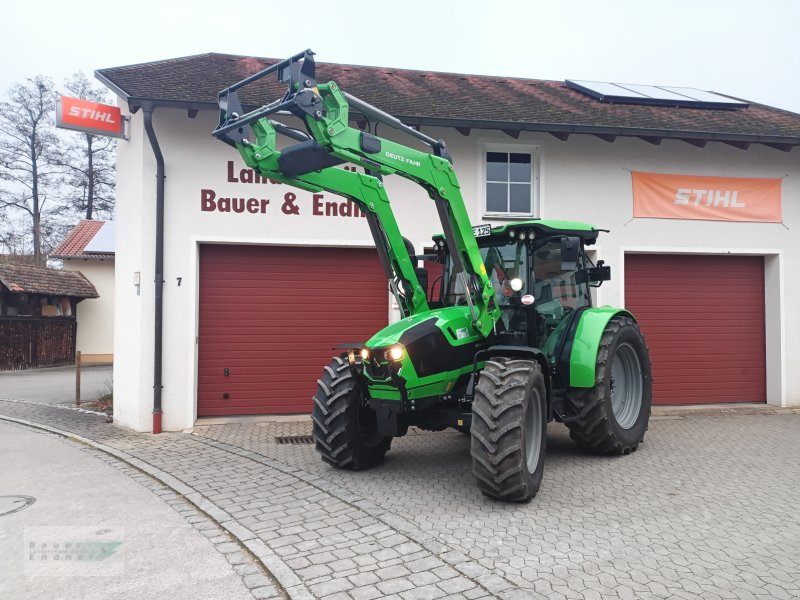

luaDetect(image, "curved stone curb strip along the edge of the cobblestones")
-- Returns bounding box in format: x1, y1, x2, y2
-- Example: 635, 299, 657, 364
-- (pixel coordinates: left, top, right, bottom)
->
0, 415, 314, 600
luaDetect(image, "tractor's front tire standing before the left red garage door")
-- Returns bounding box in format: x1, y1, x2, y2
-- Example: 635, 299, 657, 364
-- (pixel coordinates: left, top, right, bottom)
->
311, 356, 392, 471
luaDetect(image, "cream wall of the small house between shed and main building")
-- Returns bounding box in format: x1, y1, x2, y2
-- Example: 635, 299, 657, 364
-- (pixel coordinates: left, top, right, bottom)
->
63, 258, 114, 362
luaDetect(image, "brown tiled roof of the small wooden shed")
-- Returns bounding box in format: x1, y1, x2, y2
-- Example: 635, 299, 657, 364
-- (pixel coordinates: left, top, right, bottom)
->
0, 263, 99, 298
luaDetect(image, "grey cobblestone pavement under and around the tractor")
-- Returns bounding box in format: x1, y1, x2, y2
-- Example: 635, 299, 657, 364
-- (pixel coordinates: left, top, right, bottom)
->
0, 402, 800, 600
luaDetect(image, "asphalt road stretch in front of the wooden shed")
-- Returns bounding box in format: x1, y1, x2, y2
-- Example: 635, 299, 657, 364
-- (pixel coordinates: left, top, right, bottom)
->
0, 365, 113, 405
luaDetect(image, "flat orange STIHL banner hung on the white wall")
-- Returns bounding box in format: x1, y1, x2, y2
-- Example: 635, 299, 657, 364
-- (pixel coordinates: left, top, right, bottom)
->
631, 171, 782, 223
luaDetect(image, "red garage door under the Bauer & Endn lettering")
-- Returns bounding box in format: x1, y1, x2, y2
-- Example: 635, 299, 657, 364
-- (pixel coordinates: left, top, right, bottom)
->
197, 245, 388, 416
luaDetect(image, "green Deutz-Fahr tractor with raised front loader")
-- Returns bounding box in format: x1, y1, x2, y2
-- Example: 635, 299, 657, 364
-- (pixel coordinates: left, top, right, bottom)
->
214, 50, 652, 502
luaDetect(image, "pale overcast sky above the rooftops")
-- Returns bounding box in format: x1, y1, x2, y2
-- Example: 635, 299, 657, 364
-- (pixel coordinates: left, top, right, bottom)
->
0, 0, 800, 113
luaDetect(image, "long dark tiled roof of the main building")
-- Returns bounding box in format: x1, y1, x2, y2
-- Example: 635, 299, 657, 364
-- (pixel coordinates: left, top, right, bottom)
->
96, 53, 800, 151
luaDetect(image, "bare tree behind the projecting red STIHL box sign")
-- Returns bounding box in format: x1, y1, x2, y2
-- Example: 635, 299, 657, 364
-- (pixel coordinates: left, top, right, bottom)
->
63, 72, 116, 219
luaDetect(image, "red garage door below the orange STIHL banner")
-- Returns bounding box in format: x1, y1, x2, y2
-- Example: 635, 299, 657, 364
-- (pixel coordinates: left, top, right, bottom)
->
625, 254, 766, 404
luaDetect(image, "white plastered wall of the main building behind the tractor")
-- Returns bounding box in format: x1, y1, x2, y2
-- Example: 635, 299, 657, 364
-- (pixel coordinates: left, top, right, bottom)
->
115, 108, 800, 430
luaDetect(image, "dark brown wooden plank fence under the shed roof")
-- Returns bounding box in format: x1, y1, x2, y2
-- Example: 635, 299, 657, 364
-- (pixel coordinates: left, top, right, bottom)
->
0, 317, 77, 371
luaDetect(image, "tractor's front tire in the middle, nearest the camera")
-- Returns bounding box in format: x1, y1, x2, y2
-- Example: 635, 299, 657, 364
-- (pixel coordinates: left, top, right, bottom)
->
471, 358, 547, 502
